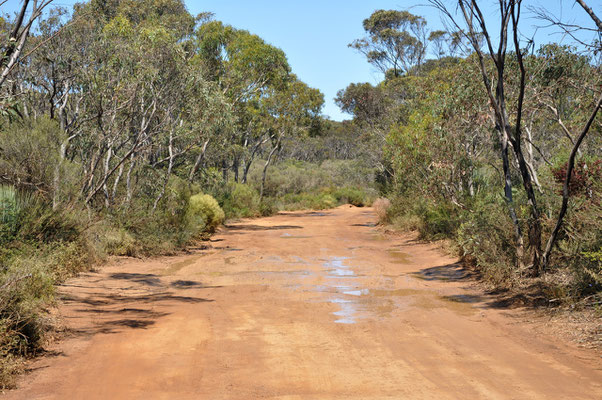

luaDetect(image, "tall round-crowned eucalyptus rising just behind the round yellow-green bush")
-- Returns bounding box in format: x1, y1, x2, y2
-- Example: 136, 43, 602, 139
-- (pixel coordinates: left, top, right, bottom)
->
195, 21, 290, 181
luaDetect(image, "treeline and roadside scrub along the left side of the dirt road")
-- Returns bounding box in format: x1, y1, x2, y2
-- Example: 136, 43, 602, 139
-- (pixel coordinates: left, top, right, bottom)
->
0, 0, 374, 387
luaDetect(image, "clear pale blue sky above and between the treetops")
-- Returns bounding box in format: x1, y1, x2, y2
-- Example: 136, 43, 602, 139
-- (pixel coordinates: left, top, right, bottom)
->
2, 0, 600, 120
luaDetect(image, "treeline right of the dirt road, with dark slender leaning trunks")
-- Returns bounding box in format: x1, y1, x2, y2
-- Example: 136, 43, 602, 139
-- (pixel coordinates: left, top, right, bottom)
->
337, 0, 602, 306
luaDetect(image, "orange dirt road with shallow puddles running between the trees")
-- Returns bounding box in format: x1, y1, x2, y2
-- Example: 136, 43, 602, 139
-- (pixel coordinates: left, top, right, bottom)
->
5, 206, 602, 400
